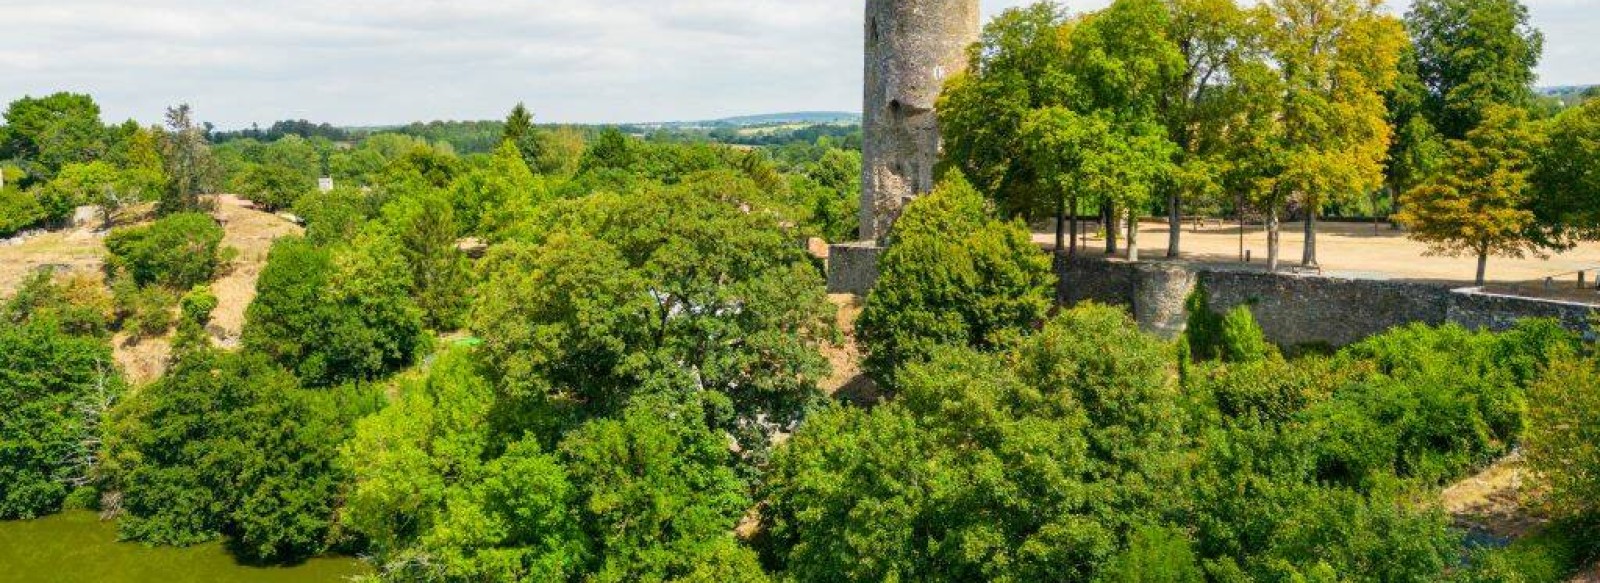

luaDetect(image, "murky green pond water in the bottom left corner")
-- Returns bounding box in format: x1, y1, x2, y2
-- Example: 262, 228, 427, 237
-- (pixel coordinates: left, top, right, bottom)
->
0, 511, 368, 583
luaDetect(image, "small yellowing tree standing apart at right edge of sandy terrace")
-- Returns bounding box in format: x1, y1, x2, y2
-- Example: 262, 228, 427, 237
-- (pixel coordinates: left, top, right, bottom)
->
1395, 107, 1544, 285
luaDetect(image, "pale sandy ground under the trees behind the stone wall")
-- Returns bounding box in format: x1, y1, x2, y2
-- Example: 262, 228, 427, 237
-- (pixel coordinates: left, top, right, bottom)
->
1034, 221, 1600, 289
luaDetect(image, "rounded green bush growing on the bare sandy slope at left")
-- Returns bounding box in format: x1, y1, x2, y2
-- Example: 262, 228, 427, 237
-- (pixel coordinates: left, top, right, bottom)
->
106, 213, 222, 290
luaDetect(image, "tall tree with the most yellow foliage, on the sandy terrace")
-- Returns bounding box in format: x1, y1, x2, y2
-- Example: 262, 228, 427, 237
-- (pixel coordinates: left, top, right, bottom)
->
1258, 0, 1406, 267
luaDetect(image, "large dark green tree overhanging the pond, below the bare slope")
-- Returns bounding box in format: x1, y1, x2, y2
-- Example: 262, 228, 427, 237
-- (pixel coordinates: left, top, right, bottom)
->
110, 349, 363, 562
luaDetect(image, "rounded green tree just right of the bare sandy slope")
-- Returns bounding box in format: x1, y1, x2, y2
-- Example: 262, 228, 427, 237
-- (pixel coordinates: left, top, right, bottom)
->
243, 231, 427, 386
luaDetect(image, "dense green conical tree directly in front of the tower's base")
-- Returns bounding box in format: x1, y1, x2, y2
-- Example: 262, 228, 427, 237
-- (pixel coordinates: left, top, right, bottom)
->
856, 172, 1053, 380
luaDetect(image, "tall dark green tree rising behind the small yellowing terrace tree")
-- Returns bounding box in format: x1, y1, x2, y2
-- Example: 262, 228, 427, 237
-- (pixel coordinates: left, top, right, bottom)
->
1405, 0, 1544, 139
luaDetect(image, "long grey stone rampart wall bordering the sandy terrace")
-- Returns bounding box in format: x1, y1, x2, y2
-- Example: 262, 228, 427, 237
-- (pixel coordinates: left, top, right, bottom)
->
1056, 259, 1595, 349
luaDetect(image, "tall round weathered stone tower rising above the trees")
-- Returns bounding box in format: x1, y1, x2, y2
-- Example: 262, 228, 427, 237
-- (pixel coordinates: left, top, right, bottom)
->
861, 0, 979, 240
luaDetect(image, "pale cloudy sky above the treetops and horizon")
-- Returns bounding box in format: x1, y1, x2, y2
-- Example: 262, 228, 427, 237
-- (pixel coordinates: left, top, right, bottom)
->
0, 0, 1600, 128
